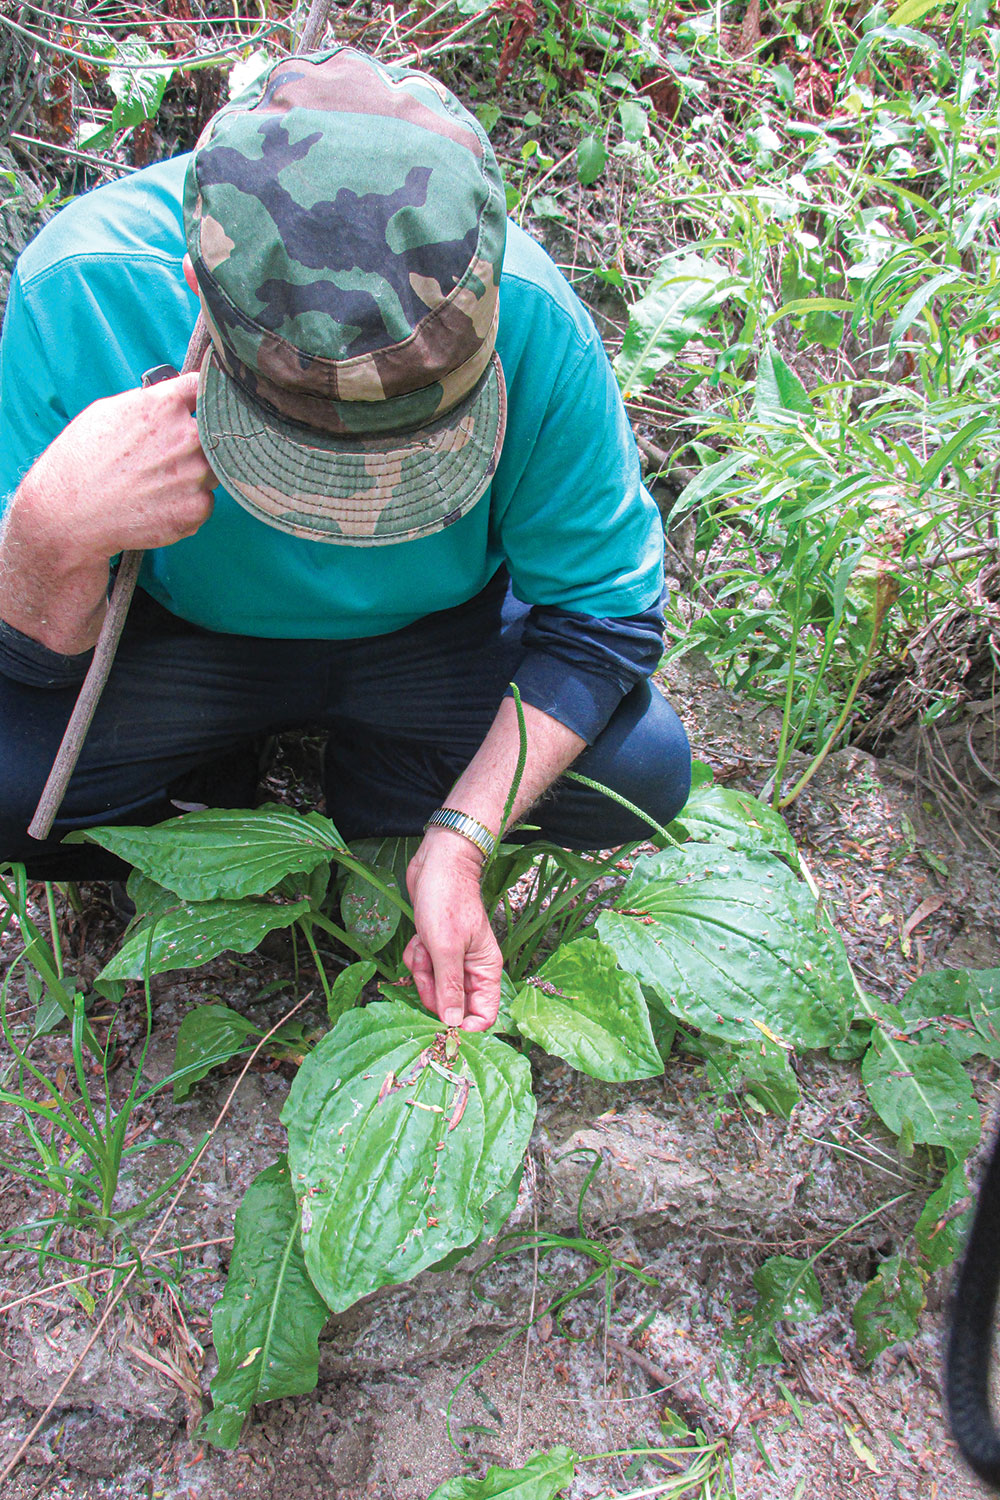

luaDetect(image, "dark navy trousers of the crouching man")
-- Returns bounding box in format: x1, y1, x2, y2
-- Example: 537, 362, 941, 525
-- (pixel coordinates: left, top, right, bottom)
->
0, 578, 691, 881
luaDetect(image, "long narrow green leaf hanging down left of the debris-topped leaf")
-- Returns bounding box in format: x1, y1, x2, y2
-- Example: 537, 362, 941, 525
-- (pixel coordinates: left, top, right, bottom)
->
198, 1157, 328, 1448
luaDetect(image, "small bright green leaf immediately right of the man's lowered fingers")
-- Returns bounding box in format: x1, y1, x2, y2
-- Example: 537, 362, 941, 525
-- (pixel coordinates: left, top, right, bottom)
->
511, 938, 663, 1083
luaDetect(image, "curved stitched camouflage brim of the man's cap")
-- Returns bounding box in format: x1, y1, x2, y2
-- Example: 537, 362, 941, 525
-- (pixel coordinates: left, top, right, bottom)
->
198, 350, 507, 548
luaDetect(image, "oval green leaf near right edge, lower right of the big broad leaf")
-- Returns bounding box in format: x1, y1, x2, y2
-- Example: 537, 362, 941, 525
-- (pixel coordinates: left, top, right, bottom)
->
861, 1031, 981, 1157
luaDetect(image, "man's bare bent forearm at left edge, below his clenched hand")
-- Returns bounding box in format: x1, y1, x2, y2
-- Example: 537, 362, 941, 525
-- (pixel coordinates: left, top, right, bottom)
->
0, 471, 108, 656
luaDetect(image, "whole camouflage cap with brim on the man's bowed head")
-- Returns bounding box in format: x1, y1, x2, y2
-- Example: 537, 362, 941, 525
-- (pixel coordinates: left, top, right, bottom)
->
184, 48, 507, 546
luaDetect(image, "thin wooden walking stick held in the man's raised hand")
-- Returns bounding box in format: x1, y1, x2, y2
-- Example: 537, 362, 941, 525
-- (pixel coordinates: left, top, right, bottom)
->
28, 0, 331, 839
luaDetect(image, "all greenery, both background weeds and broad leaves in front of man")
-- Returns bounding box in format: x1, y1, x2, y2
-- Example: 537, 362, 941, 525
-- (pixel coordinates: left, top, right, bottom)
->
0, 0, 1000, 1500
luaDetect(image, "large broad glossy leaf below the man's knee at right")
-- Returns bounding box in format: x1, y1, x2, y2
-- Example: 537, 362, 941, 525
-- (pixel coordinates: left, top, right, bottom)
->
597, 845, 853, 1047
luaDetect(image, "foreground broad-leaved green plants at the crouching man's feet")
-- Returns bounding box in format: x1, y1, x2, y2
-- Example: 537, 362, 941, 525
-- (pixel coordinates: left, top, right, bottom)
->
3, 779, 983, 1448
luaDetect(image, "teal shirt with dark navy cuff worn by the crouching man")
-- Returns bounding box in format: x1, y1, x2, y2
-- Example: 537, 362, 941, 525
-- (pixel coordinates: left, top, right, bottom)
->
0, 158, 663, 740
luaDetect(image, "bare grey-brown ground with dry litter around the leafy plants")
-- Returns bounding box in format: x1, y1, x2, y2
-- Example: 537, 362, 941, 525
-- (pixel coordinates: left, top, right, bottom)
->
0, 659, 1000, 1500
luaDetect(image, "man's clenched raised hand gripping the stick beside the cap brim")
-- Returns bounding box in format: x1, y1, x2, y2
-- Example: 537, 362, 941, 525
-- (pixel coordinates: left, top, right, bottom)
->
16, 374, 217, 563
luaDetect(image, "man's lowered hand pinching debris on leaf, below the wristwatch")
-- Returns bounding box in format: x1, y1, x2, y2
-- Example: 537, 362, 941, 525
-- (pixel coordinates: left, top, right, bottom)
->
403, 828, 502, 1031
